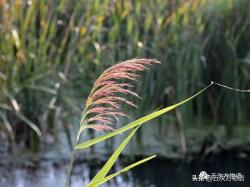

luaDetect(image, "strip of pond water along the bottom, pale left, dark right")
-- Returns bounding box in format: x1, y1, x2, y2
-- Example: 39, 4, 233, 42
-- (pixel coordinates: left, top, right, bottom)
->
0, 154, 250, 187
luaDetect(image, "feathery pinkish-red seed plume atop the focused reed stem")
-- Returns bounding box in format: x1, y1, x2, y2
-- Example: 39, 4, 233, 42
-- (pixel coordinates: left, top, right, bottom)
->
81, 59, 160, 132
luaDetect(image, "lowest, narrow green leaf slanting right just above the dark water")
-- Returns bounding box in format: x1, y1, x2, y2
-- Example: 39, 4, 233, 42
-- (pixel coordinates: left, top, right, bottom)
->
86, 155, 156, 187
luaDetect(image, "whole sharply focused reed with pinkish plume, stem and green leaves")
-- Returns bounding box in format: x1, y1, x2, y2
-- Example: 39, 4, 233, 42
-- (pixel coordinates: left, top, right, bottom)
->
65, 59, 213, 187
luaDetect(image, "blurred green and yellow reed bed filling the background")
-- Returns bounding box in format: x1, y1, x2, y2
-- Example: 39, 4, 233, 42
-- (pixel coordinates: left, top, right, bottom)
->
0, 0, 250, 151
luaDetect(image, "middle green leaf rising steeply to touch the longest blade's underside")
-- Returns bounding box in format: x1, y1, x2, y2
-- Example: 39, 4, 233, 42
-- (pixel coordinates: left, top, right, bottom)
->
87, 125, 143, 184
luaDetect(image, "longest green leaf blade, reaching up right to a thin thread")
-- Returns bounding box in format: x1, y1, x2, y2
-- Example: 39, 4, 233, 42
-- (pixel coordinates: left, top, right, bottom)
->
75, 83, 213, 149
